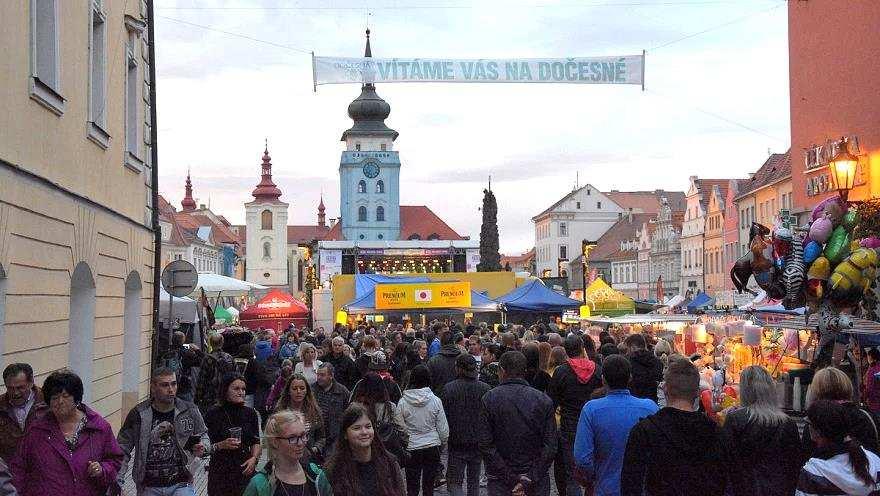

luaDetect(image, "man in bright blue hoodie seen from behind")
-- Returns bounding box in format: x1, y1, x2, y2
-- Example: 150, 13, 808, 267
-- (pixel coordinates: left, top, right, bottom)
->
574, 355, 658, 496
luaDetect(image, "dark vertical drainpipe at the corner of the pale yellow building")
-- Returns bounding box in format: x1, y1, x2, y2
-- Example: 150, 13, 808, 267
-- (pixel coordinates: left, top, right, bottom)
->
147, 0, 162, 369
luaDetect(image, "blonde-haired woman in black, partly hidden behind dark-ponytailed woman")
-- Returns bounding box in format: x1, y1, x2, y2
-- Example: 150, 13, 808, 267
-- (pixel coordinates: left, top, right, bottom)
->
802, 367, 880, 456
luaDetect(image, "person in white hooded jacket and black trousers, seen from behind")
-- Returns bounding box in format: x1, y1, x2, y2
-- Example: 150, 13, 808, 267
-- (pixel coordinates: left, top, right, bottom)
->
394, 365, 449, 496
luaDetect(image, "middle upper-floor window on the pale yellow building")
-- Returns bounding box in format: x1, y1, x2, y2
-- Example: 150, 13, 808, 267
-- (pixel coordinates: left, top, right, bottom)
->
89, 0, 110, 149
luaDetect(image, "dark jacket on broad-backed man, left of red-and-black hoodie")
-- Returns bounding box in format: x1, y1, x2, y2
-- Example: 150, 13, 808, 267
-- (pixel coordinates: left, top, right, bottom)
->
480, 379, 557, 484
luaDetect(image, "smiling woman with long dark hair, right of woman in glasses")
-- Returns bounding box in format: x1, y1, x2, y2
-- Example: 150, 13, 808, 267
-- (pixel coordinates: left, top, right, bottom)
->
318, 403, 404, 496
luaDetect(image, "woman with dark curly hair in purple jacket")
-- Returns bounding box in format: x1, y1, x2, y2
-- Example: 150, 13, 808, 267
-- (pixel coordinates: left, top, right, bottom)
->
11, 370, 122, 496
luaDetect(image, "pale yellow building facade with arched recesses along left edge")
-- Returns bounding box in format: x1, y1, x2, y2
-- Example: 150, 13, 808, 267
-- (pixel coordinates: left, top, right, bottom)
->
0, 0, 153, 427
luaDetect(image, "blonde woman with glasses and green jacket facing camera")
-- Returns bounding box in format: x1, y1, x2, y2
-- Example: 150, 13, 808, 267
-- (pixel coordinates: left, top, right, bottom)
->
242, 410, 321, 496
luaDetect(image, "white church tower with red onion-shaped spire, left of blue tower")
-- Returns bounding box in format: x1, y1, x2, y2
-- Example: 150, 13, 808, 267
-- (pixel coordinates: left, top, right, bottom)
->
244, 143, 288, 286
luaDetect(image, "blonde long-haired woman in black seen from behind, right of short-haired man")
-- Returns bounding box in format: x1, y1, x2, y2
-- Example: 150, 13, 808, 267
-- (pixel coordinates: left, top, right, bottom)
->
723, 365, 802, 496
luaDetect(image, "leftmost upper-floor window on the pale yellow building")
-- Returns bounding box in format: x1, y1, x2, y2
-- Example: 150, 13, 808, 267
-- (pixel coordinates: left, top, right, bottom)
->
30, 0, 64, 115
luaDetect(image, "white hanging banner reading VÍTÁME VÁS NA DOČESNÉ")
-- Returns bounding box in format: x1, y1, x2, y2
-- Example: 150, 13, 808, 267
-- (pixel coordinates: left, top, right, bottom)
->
312, 53, 645, 87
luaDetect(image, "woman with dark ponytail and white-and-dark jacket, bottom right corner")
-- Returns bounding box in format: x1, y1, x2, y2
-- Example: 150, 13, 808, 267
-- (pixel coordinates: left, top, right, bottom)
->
796, 400, 880, 495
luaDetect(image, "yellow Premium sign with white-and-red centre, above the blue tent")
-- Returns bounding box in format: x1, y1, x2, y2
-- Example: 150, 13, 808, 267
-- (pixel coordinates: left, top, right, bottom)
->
376, 281, 471, 310
